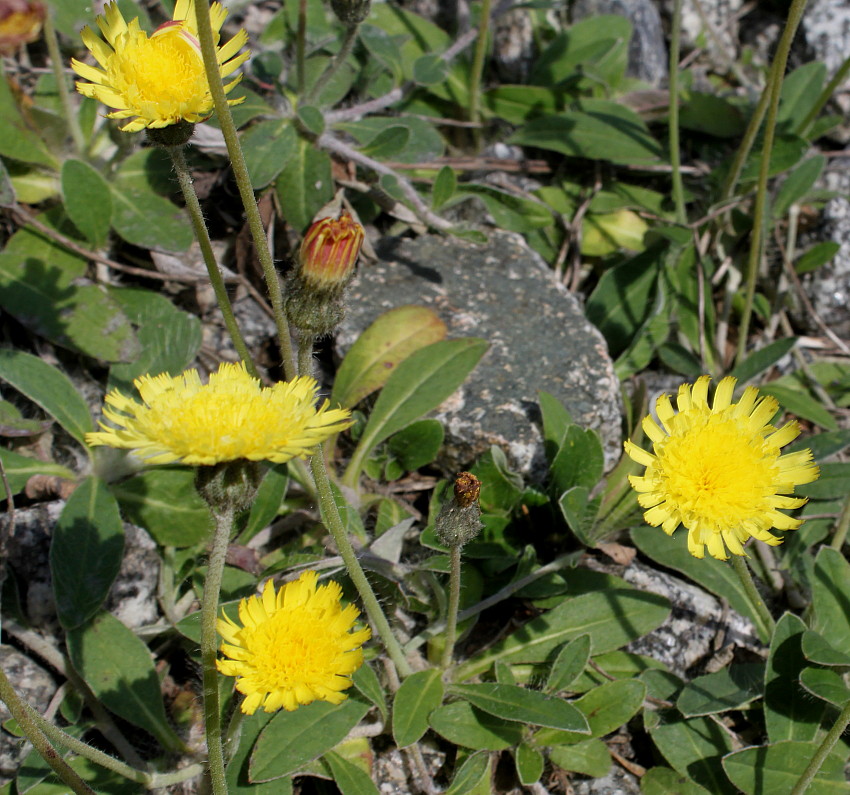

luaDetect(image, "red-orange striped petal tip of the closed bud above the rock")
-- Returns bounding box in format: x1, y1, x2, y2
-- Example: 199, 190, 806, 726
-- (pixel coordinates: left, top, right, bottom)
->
301, 210, 363, 290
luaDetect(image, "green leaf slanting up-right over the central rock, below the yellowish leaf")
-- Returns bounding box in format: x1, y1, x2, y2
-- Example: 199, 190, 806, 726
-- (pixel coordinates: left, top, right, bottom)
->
343, 337, 488, 484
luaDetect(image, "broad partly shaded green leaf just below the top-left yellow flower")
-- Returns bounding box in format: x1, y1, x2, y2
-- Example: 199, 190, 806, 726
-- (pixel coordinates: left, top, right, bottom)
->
109, 149, 193, 252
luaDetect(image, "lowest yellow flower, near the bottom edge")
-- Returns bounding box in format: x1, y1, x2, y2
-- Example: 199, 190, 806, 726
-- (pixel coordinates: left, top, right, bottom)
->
216, 571, 371, 715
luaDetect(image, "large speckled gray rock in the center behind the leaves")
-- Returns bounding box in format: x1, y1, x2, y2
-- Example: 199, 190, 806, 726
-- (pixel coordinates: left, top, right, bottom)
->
338, 231, 622, 477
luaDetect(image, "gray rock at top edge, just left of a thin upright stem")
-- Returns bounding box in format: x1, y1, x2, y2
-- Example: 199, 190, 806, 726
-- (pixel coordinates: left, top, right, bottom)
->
572, 0, 668, 88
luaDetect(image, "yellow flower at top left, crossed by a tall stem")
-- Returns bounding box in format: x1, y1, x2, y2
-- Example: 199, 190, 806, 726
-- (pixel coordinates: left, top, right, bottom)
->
71, 0, 249, 132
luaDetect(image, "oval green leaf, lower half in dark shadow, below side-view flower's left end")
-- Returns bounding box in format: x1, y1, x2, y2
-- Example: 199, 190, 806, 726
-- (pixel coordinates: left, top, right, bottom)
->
50, 478, 124, 629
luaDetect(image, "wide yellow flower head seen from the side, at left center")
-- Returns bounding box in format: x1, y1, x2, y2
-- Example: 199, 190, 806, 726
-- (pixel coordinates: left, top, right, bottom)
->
86, 362, 351, 466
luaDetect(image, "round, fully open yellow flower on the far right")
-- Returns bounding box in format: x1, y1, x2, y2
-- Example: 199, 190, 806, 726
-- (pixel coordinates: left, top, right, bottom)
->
626, 375, 819, 560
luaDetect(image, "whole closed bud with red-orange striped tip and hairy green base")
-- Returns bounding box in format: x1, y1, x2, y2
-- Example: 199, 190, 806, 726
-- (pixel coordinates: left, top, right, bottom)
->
286, 210, 363, 336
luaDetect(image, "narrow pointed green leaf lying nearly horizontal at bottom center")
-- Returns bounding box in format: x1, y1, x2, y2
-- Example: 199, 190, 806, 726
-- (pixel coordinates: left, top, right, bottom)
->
449, 682, 589, 734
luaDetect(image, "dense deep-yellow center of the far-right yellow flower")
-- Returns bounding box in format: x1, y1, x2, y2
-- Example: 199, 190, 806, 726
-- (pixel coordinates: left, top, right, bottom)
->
656, 412, 779, 527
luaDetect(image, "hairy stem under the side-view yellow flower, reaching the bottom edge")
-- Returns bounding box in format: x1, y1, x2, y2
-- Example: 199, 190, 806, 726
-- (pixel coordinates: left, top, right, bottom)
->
201, 508, 233, 795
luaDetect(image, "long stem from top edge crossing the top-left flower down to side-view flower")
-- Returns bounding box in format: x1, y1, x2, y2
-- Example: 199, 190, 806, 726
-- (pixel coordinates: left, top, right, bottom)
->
195, 3, 295, 381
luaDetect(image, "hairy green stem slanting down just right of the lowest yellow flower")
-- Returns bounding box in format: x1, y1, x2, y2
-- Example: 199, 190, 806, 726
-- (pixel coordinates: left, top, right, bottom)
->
310, 453, 412, 678
